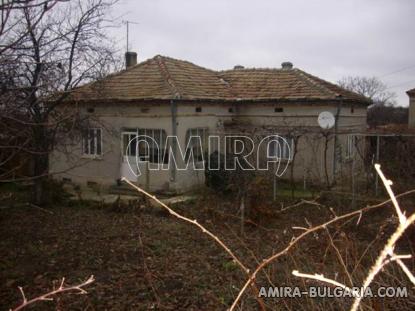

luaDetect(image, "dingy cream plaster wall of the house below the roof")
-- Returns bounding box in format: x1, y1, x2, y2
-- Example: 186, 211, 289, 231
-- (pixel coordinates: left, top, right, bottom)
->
50, 102, 366, 191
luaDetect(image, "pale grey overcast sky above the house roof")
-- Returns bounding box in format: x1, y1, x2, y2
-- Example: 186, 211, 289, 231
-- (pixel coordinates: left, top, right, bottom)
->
112, 0, 415, 106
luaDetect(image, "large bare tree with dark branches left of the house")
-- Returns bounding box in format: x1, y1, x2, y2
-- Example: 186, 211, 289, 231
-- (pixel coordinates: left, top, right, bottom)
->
0, 0, 117, 204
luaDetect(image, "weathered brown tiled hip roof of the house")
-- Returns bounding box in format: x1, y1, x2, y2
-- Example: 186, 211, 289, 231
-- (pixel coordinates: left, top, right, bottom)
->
72, 55, 370, 104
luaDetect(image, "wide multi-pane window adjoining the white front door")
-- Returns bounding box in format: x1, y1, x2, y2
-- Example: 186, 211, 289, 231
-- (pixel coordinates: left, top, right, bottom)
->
123, 129, 169, 163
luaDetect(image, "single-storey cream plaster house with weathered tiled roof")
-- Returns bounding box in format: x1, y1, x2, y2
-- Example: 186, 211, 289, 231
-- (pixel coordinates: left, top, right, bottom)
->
50, 52, 371, 191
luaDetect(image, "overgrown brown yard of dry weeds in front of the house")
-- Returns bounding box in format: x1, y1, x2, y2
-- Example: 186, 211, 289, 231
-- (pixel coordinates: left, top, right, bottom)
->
0, 189, 415, 310
